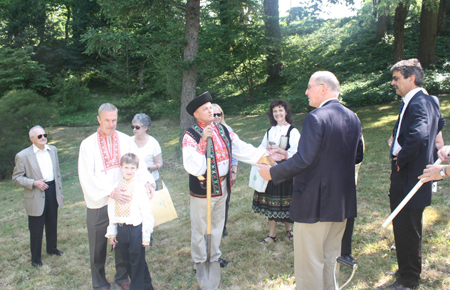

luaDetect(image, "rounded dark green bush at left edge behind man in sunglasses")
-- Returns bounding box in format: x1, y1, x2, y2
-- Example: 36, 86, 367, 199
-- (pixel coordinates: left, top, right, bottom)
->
0, 90, 58, 179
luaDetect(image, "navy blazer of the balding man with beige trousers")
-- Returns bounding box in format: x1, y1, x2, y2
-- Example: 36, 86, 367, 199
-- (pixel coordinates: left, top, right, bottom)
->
270, 99, 363, 223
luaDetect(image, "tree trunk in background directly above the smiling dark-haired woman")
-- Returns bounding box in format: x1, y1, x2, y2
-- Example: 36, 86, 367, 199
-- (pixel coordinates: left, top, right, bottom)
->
264, 0, 282, 83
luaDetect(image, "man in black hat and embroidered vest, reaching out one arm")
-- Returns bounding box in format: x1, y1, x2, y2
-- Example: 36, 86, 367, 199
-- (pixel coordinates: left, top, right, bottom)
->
182, 92, 265, 267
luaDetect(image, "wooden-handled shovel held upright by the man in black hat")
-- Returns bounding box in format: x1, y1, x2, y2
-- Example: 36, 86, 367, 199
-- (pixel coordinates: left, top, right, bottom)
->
197, 137, 220, 290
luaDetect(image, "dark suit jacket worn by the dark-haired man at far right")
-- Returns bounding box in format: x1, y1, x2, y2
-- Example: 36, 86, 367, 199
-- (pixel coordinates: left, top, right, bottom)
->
390, 91, 445, 209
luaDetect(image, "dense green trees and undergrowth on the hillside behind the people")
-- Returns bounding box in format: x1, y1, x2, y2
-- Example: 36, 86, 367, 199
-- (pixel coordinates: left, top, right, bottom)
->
0, 0, 450, 126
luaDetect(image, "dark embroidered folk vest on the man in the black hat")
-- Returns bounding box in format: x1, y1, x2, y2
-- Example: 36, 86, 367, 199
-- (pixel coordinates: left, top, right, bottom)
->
185, 123, 232, 198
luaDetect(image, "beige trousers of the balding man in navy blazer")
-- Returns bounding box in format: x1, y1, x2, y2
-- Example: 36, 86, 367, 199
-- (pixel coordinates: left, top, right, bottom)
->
294, 220, 347, 290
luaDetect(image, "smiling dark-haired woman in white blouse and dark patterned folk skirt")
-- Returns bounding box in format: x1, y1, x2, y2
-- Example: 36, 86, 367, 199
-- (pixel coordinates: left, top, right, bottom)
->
253, 100, 300, 244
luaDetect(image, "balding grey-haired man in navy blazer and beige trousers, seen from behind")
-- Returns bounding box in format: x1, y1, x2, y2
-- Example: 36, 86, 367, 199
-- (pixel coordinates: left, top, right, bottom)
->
258, 71, 363, 290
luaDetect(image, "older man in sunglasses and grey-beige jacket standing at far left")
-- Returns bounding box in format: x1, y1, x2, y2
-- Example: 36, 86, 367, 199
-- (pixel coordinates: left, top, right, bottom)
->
12, 126, 64, 267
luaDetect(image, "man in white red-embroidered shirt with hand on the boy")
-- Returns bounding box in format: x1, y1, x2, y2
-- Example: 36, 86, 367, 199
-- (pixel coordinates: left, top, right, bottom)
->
78, 103, 155, 290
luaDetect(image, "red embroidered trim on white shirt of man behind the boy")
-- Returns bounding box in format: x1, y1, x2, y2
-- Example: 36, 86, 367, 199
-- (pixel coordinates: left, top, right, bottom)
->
97, 128, 121, 174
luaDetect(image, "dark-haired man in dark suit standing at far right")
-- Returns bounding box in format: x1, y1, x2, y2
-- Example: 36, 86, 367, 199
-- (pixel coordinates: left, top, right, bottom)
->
383, 59, 445, 289
